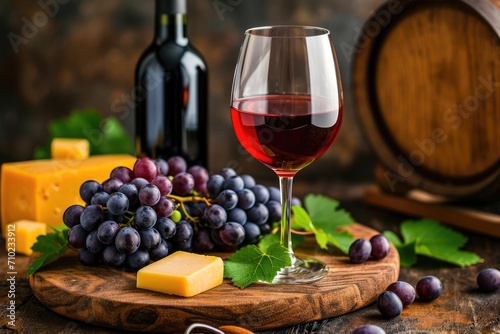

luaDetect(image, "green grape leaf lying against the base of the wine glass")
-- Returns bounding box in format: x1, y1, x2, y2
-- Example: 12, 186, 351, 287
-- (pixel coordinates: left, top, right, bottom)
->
224, 243, 292, 289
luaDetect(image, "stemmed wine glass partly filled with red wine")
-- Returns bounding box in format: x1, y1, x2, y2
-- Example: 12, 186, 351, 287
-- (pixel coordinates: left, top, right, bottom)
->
231, 26, 344, 283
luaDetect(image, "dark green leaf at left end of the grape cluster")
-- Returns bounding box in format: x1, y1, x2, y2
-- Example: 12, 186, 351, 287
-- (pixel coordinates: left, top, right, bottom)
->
27, 227, 70, 277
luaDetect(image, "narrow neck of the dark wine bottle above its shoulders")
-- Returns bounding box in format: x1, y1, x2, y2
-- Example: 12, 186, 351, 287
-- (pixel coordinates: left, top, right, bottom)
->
154, 0, 188, 45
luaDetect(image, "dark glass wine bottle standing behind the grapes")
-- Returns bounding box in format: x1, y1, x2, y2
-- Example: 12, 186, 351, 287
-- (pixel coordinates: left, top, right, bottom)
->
135, 0, 208, 166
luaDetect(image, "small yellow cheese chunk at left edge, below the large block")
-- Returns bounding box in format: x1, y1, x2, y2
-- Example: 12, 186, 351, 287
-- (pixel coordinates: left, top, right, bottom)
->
5, 220, 47, 255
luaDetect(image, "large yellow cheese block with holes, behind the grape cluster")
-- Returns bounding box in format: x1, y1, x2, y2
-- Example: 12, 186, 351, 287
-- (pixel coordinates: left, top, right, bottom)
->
0, 155, 136, 235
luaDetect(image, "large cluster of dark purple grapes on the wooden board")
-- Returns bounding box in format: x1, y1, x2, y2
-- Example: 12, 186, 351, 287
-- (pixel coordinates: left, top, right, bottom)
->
63, 156, 286, 270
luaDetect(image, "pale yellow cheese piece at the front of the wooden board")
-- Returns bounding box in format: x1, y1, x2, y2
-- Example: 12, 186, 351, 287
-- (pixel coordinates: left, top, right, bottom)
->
137, 251, 224, 297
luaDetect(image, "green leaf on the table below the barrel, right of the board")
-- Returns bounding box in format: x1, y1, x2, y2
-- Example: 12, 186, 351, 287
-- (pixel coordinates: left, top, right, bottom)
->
384, 219, 482, 267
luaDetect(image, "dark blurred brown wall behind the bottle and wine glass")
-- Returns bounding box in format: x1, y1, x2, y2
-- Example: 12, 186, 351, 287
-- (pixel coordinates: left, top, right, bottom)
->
0, 0, 383, 186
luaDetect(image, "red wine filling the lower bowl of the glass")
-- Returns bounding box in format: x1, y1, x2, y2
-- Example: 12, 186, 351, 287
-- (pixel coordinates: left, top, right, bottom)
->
231, 95, 343, 176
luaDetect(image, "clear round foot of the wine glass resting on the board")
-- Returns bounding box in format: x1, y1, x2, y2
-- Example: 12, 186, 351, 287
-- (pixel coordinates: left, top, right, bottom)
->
272, 256, 328, 284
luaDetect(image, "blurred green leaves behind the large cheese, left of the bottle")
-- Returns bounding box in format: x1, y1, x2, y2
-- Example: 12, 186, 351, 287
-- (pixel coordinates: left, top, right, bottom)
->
34, 109, 132, 159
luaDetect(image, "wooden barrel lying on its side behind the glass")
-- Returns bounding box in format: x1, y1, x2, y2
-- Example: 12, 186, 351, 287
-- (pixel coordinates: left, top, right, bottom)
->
352, 0, 500, 200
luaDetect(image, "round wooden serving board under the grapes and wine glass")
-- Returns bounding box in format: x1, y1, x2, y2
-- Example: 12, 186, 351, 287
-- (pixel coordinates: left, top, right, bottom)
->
29, 224, 399, 332
